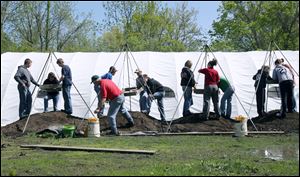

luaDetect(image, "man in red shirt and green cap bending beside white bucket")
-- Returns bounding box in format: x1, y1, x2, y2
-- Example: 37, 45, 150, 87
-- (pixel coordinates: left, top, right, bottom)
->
95, 79, 134, 135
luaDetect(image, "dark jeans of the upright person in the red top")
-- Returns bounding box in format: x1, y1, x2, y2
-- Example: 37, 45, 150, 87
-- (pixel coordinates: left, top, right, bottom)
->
203, 85, 220, 119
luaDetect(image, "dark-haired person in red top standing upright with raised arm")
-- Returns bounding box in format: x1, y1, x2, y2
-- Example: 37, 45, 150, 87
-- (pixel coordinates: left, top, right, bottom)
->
198, 59, 220, 120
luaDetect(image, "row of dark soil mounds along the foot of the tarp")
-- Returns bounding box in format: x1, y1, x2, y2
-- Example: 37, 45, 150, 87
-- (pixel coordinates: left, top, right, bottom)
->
1, 111, 299, 136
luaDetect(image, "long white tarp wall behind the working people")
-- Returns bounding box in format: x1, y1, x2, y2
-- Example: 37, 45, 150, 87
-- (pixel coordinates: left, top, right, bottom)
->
1, 51, 299, 126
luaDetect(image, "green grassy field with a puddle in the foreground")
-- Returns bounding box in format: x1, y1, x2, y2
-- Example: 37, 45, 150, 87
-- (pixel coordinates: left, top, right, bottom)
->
1, 133, 299, 176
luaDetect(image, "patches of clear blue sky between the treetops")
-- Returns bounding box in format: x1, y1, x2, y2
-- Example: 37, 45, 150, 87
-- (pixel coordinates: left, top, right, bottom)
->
75, 1, 221, 33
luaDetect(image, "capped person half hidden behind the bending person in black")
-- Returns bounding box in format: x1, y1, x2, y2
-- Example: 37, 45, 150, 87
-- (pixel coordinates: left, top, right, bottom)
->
134, 69, 150, 113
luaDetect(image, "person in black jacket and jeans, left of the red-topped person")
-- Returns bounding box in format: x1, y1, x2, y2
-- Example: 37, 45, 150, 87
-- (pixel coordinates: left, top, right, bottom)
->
180, 60, 196, 116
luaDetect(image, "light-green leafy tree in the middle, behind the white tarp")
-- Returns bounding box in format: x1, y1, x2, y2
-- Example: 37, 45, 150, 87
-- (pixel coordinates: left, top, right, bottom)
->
103, 1, 201, 51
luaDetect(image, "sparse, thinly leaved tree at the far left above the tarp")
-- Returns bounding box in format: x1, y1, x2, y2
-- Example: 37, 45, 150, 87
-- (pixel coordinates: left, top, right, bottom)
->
1, 1, 96, 52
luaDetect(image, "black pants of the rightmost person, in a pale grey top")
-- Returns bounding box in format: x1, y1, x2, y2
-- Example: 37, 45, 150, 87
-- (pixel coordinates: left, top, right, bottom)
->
279, 80, 293, 117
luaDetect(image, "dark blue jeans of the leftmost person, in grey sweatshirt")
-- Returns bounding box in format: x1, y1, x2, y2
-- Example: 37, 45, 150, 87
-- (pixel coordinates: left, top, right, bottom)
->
18, 84, 32, 118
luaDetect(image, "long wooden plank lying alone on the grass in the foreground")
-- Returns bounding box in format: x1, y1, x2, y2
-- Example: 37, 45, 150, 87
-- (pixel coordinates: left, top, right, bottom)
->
20, 145, 156, 155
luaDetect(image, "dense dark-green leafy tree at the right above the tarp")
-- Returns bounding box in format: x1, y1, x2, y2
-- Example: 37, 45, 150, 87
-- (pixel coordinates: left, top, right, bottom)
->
210, 1, 299, 51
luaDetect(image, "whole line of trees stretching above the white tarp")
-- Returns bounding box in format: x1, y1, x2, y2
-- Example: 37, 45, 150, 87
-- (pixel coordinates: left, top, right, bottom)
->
1, 1, 299, 53
